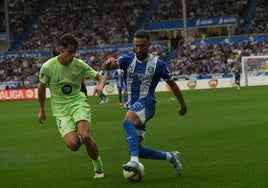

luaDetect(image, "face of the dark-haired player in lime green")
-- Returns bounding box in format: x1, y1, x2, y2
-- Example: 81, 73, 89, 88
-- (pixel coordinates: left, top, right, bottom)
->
60, 45, 77, 65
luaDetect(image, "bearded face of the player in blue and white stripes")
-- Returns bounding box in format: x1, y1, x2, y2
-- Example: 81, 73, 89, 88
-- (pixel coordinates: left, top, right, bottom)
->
134, 38, 150, 61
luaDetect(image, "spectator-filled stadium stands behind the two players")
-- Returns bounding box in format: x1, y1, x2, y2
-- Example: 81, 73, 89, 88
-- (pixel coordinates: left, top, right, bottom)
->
0, 0, 268, 92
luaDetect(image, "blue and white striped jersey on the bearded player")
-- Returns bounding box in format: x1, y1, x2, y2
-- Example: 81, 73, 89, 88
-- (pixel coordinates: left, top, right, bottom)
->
118, 53, 172, 104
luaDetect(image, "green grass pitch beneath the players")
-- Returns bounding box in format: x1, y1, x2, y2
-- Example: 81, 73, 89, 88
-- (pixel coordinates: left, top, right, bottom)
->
0, 86, 268, 188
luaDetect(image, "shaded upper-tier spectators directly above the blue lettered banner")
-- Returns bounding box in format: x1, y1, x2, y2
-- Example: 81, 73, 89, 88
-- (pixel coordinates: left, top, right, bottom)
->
151, 0, 248, 22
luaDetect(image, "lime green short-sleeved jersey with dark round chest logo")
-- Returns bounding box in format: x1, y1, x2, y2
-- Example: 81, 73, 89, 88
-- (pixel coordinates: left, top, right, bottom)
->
39, 57, 97, 116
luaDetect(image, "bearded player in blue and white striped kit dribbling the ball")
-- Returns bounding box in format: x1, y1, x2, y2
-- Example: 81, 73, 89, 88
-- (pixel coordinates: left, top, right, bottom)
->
103, 30, 187, 176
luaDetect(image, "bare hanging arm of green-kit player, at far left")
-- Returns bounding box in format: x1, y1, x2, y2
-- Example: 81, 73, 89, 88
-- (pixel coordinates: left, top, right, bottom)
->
37, 82, 46, 123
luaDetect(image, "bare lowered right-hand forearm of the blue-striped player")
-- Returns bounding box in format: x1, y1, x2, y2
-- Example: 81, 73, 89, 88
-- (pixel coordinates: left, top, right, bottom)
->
166, 80, 187, 116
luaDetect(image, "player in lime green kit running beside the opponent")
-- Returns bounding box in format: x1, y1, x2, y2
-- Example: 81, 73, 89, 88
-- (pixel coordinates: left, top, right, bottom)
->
38, 34, 106, 178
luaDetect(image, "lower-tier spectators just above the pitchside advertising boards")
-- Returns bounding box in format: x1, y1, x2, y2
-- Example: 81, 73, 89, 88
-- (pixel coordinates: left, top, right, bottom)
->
0, 40, 268, 87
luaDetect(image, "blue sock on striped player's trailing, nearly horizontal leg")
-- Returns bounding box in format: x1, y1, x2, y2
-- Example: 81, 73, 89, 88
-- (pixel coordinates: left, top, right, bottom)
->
139, 146, 167, 160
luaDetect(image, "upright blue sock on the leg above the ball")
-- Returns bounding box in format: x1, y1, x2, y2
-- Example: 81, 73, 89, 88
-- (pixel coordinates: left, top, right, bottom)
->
123, 120, 139, 157
